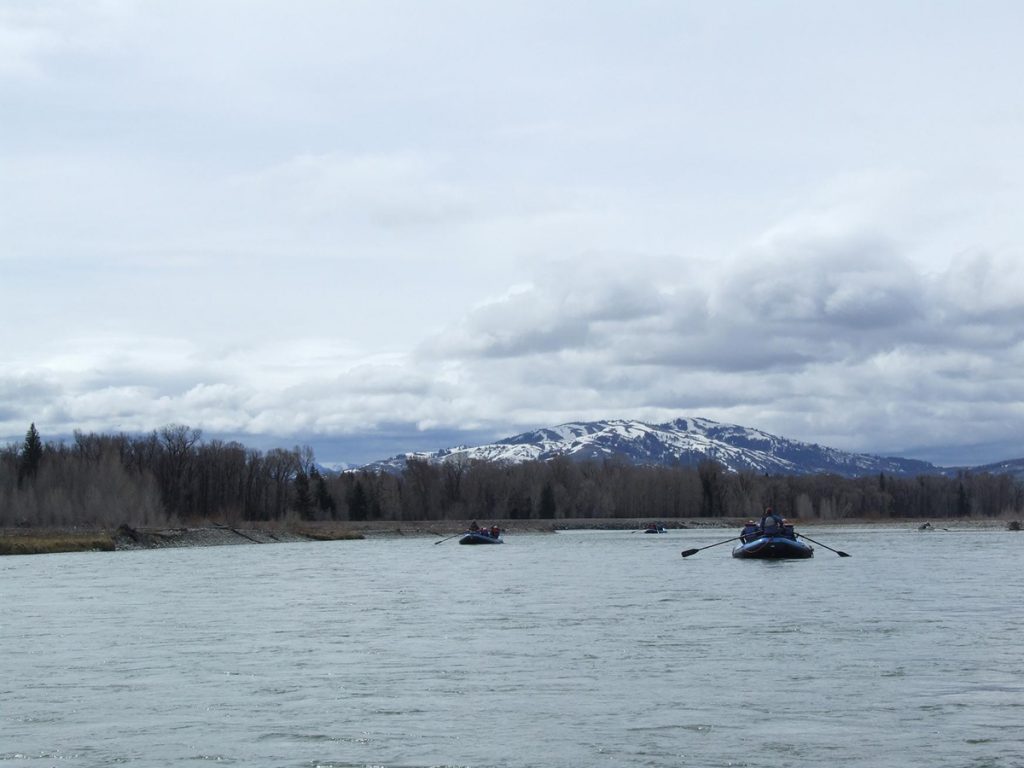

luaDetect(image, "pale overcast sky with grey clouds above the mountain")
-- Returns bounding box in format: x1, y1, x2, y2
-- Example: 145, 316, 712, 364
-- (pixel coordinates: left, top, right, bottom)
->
0, 0, 1024, 466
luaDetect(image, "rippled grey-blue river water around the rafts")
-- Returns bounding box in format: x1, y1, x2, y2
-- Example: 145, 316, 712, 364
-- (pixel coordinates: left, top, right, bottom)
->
0, 528, 1024, 768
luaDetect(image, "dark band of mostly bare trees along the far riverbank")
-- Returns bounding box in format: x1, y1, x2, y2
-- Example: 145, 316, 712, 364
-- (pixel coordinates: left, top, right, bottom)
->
0, 424, 1024, 527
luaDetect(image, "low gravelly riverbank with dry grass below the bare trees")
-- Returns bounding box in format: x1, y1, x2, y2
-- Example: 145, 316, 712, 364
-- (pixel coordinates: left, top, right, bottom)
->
0, 517, 1021, 556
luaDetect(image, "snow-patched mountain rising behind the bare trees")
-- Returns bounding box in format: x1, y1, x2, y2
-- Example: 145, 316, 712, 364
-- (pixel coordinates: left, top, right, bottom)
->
362, 418, 942, 477
